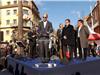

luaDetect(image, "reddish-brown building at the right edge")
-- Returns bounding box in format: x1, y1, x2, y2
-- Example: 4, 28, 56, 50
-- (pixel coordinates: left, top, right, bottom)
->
87, 1, 100, 33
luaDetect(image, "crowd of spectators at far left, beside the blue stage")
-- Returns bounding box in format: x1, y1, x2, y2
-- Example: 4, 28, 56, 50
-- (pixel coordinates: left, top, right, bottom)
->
0, 40, 17, 70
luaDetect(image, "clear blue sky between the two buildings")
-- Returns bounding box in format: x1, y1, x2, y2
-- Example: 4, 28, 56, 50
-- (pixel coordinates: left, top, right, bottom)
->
34, 0, 96, 29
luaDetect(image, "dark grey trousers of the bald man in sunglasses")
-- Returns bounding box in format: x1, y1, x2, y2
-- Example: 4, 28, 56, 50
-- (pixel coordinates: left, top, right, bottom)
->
39, 37, 49, 62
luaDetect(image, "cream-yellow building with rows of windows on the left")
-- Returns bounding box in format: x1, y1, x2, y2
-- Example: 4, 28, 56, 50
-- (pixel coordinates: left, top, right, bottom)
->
0, 0, 40, 41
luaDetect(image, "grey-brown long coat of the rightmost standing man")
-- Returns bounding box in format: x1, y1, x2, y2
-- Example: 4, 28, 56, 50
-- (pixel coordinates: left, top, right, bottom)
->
77, 26, 89, 48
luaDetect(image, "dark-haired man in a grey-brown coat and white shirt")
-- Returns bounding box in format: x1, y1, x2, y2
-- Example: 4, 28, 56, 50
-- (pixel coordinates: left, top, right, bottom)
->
77, 19, 89, 60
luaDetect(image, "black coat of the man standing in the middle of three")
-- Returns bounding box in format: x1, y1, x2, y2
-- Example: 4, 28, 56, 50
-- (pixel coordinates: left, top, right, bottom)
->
62, 25, 75, 46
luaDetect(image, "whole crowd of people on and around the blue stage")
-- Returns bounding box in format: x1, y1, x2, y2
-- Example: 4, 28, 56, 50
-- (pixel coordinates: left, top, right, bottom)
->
0, 13, 97, 66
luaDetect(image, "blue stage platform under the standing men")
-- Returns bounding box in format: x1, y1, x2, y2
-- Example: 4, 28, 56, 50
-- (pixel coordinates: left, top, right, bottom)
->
7, 56, 100, 75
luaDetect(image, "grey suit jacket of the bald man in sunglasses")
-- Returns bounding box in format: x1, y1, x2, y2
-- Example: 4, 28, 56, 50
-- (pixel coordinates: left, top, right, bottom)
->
38, 21, 53, 38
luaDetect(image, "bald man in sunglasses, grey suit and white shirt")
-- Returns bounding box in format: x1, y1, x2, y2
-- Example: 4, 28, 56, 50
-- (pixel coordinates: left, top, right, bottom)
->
38, 13, 53, 63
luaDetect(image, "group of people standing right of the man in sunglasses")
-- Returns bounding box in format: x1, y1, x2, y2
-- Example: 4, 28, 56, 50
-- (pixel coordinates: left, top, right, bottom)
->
57, 19, 96, 61
